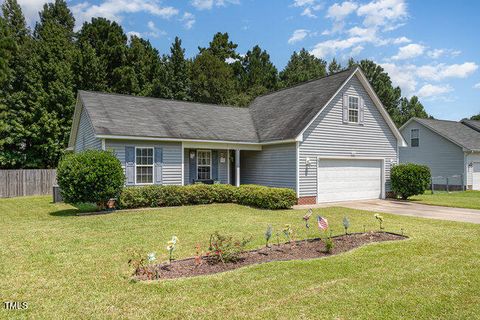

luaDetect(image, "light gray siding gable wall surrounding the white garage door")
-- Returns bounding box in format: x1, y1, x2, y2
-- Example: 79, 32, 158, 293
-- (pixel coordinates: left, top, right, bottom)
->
299, 76, 398, 197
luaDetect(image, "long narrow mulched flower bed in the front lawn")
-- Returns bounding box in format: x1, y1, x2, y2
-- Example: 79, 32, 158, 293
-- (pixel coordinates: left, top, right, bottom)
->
134, 231, 407, 280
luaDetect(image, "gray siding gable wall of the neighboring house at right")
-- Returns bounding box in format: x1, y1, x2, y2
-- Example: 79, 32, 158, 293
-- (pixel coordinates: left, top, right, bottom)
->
400, 121, 465, 183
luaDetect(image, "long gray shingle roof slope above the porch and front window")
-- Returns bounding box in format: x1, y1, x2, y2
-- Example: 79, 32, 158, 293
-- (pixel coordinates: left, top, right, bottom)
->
79, 91, 258, 142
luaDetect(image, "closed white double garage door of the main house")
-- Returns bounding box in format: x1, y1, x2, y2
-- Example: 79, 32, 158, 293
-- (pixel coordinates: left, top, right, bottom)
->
317, 159, 382, 202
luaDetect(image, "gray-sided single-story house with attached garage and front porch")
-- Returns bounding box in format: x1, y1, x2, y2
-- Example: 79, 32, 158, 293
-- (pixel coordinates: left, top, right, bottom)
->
69, 68, 405, 204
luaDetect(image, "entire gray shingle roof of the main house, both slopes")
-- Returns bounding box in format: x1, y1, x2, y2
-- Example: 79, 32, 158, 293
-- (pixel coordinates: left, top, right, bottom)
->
79, 68, 356, 142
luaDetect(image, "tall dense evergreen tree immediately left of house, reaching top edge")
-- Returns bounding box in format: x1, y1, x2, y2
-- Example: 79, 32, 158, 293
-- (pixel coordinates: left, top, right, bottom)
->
31, 0, 76, 168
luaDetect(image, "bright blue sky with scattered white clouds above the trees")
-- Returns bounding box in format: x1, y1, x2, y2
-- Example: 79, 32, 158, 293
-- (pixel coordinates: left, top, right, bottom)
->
14, 0, 480, 120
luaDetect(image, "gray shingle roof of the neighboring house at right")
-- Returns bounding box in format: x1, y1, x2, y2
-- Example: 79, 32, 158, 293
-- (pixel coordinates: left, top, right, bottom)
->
415, 118, 480, 150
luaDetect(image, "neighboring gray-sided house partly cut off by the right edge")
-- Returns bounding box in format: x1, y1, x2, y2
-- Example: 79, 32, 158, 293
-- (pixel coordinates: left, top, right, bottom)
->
400, 118, 480, 190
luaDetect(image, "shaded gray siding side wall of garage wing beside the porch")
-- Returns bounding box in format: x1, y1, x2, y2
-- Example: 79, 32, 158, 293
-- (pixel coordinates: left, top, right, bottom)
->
240, 143, 297, 190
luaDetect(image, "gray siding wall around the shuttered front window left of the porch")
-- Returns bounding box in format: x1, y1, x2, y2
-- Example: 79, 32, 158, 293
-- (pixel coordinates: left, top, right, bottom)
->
105, 140, 182, 185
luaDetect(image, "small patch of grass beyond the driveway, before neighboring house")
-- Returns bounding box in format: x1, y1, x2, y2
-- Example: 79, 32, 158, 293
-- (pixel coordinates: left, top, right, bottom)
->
410, 191, 480, 209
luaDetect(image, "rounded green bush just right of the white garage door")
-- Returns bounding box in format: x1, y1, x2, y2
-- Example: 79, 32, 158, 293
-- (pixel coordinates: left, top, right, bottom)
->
390, 163, 431, 200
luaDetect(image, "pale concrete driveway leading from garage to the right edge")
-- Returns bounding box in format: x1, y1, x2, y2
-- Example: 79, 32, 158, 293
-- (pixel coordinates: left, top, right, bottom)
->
294, 199, 480, 224
